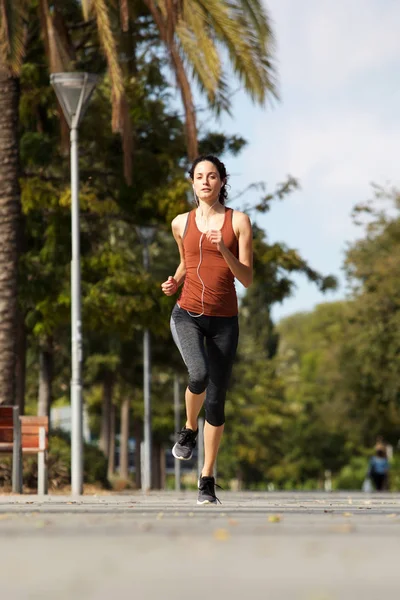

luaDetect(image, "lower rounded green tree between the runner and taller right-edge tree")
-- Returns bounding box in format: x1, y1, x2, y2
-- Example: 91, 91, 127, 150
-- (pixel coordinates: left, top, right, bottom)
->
276, 302, 354, 484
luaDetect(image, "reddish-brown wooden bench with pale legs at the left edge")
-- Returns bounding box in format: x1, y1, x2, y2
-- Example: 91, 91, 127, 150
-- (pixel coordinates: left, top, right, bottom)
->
0, 406, 49, 494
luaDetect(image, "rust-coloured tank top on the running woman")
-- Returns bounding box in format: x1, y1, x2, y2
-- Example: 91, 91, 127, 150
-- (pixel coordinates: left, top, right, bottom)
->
178, 208, 239, 317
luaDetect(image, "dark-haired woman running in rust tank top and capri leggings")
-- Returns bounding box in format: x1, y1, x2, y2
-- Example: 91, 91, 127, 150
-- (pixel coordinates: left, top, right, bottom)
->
161, 155, 253, 504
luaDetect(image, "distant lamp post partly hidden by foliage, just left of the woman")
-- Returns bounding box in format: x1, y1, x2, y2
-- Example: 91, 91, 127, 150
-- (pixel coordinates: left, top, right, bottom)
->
136, 226, 156, 492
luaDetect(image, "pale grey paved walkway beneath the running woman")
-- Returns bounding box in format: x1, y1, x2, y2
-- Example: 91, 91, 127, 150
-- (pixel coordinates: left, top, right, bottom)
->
0, 491, 400, 600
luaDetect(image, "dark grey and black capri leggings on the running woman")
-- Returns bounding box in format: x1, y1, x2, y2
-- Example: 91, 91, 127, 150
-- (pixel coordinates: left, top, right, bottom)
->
171, 304, 239, 427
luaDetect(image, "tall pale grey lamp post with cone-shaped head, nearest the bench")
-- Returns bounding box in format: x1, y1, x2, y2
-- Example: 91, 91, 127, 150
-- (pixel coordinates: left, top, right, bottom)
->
50, 73, 98, 495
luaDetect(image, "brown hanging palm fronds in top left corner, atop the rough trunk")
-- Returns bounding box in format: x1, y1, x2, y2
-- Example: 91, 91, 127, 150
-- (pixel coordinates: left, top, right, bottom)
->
0, 0, 28, 75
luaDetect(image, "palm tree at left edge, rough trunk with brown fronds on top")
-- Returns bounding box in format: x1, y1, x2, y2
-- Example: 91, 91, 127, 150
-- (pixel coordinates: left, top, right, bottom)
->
0, 0, 27, 404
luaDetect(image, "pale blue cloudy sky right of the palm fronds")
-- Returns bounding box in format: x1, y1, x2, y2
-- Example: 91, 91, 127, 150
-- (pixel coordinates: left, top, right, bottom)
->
205, 0, 400, 320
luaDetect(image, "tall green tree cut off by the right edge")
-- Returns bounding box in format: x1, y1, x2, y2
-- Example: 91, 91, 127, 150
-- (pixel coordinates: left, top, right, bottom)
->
342, 186, 400, 445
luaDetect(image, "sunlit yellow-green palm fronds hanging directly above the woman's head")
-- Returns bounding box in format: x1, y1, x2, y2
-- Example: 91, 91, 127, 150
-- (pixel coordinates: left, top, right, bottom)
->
144, 0, 277, 160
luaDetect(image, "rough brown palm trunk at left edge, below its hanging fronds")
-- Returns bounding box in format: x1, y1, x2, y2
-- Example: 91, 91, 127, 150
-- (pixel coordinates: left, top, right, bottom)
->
0, 71, 21, 404
